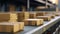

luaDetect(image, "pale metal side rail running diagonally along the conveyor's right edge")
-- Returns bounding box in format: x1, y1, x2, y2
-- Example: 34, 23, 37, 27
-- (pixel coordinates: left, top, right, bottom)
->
25, 16, 60, 34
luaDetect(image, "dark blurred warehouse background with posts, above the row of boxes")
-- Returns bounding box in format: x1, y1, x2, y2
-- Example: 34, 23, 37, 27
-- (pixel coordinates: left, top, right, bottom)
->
0, 0, 60, 12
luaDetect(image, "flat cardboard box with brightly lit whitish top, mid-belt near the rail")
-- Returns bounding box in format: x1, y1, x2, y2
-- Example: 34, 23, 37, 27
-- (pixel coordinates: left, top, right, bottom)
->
24, 19, 43, 26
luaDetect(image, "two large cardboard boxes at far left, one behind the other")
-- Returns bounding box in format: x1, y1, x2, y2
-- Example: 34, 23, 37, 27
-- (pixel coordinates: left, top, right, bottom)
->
0, 13, 24, 32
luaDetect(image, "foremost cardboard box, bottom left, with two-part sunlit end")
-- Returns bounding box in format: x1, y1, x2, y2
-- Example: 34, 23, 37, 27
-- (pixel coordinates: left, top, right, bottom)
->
0, 22, 24, 32
